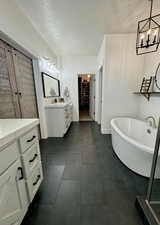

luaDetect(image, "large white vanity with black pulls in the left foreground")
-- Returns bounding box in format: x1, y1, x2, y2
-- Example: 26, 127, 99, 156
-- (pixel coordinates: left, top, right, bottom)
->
0, 119, 43, 225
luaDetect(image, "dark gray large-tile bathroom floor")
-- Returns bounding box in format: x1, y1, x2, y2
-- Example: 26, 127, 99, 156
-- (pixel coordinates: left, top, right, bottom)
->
23, 122, 148, 225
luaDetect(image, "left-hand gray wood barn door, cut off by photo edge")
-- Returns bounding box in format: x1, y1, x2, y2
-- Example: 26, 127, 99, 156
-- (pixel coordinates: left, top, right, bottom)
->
0, 40, 21, 119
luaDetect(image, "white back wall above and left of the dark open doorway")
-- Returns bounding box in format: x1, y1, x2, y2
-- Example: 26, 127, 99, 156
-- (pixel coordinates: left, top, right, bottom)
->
61, 56, 97, 121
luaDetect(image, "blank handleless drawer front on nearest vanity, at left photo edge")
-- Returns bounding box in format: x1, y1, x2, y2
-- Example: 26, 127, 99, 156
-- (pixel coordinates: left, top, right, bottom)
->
0, 141, 19, 174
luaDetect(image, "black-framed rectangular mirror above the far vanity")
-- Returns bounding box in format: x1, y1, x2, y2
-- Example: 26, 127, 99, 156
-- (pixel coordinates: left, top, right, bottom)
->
42, 73, 60, 98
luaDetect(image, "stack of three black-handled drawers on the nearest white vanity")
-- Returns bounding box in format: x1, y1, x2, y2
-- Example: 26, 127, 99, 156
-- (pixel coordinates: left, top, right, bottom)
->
20, 127, 43, 203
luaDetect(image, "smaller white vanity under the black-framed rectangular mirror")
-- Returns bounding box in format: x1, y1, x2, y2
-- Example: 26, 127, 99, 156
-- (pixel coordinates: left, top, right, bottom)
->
45, 103, 73, 137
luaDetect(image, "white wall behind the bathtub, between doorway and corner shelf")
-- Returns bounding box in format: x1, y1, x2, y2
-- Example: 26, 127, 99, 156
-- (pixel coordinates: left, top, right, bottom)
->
98, 34, 144, 133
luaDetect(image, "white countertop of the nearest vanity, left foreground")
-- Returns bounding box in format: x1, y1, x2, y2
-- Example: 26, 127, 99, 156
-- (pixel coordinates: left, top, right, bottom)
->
0, 119, 39, 147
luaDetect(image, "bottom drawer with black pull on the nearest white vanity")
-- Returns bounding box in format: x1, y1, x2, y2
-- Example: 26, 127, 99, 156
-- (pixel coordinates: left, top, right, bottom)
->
27, 164, 43, 202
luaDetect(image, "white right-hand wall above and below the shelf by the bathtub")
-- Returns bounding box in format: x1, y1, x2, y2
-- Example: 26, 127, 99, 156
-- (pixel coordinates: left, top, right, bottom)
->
139, 50, 160, 123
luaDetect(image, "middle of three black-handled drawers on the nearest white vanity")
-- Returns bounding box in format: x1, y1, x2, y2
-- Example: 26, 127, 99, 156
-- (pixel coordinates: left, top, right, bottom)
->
22, 140, 41, 177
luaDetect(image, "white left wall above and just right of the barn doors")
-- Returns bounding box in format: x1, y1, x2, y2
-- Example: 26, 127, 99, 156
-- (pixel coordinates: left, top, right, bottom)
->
0, 0, 56, 138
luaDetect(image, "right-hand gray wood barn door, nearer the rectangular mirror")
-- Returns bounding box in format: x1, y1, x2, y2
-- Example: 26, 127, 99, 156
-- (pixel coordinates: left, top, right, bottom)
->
12, 50, 38, 118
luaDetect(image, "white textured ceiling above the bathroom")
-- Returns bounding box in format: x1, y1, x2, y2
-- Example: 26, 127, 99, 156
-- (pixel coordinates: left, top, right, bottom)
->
14, 0, 160, 55
